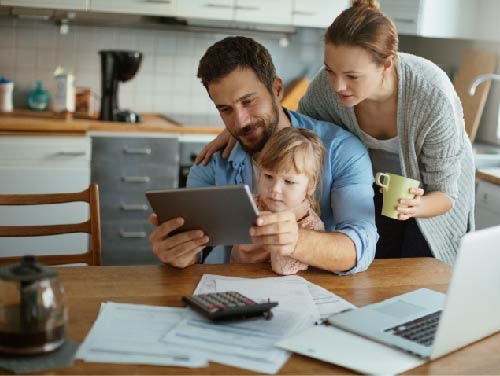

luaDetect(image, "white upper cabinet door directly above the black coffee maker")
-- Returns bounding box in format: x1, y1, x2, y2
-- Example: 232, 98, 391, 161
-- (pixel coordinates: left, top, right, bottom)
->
89, 0, 177, 16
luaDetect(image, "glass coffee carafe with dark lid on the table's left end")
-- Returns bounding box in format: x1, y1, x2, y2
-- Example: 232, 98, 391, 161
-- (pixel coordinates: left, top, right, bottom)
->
0, 256, 68, 355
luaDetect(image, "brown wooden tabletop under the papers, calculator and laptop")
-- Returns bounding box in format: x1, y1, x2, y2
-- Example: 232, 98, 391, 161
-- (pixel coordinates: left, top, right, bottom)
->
35, 258, 500, 375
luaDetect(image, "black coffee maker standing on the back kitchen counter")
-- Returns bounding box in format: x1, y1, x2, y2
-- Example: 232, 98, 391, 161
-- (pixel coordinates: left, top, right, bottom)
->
99, 50, 142, 123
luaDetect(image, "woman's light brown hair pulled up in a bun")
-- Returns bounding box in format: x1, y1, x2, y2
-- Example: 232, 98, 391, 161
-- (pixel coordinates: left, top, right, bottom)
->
325, 0, 398, 66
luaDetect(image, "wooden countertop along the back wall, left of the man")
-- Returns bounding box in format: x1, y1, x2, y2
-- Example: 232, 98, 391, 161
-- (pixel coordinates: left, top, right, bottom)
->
0, 110, 223, 136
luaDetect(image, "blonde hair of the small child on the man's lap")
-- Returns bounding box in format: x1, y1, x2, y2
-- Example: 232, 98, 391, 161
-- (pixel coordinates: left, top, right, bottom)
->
256, 127, 326, 213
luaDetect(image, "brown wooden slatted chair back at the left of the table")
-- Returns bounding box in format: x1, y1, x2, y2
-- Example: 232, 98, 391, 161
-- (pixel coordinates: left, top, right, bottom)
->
0, 184, 101, 265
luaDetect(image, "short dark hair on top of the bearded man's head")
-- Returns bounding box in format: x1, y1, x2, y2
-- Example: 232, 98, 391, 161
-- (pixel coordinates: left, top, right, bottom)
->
198, 36, 276, 93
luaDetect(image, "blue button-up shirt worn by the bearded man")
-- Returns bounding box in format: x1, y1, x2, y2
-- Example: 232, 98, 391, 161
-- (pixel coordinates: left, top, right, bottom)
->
187, 110, 378, 274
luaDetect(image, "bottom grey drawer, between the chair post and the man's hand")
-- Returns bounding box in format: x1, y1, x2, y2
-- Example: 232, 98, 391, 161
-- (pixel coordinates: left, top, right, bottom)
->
102, 220, 160, 265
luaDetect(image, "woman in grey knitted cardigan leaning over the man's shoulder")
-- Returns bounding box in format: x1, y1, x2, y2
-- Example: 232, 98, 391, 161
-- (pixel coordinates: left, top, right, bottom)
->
199, 0, 474, 264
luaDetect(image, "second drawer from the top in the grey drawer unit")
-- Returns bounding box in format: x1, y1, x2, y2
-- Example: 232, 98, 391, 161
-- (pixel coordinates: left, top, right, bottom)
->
92, 163, 179, 194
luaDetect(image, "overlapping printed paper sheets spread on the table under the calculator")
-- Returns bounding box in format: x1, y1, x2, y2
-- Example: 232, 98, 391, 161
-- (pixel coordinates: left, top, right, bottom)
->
77, 274, 354, 373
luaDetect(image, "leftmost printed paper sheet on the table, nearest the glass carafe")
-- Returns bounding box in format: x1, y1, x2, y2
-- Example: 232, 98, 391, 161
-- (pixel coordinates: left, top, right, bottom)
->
77, 303, 208, 367
